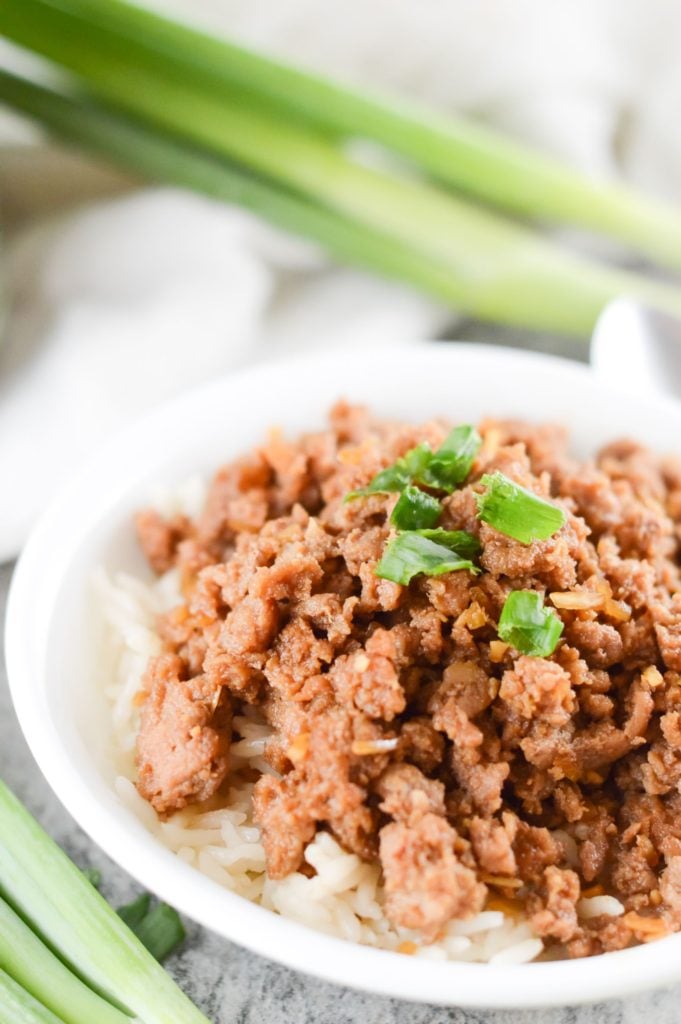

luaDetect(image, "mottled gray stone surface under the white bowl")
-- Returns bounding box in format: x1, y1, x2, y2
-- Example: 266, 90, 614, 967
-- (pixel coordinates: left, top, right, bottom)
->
0, 337, 681, 1024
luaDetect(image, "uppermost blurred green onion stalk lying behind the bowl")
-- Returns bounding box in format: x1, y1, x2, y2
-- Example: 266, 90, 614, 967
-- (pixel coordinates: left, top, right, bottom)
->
3, 0, 681, 268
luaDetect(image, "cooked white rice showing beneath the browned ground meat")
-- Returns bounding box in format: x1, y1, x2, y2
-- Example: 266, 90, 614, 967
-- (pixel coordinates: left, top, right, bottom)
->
94, 481, 548, 964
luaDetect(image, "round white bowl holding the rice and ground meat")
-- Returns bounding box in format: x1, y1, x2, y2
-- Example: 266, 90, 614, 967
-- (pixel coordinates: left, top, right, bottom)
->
6, 339, 681, 1008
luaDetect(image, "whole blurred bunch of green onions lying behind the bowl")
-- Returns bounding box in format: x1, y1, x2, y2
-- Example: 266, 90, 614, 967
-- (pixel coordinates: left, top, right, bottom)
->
0, 0, 681, 334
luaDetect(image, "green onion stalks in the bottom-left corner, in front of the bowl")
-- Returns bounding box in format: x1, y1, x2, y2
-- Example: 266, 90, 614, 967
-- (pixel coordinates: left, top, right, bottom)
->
0, 782, 208, 1024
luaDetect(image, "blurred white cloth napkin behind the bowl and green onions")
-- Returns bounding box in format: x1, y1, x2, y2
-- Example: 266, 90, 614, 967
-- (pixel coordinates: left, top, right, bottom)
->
0, 0, 681, 560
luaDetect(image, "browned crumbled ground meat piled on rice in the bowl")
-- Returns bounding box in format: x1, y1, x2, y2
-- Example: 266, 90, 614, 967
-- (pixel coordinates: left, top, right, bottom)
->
137, 402, 681, 956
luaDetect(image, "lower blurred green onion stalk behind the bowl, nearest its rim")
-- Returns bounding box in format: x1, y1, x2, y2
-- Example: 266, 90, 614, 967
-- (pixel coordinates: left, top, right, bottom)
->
0, 0, 681, 335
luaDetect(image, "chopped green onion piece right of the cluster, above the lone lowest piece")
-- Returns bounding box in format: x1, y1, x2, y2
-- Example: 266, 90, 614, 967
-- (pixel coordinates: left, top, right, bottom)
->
475, 472, 565, 544
